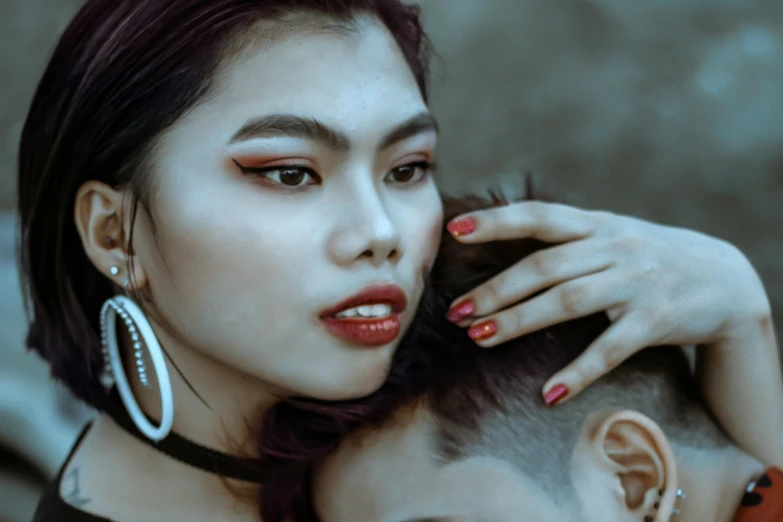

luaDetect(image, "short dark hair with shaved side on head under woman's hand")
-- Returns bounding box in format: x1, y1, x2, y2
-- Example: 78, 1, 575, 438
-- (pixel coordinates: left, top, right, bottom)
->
415, 199, 728, 496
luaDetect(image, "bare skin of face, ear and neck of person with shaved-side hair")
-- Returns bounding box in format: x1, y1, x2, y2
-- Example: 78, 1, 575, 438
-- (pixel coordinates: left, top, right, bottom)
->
313, 405, 764, 522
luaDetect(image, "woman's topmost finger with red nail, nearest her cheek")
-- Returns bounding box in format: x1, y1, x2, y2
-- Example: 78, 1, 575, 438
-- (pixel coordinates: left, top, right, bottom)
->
447, 201, 598, 243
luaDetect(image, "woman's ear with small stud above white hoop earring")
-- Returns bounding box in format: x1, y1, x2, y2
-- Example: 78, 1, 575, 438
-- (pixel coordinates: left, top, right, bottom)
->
74, 181, 147, 289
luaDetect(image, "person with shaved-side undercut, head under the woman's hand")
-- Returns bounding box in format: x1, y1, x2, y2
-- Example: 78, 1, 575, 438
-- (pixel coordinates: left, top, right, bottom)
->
264, 192, 783, 522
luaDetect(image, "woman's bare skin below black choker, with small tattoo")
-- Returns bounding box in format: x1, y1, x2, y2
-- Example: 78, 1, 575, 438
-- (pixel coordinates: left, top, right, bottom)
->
66, 415, 259, 522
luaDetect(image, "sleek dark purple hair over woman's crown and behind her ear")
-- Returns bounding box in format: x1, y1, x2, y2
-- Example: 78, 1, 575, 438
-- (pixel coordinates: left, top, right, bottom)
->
18, 0, 427, 409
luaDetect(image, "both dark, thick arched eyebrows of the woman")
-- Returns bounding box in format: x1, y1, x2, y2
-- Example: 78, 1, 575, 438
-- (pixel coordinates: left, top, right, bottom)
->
229, 112, 438, 152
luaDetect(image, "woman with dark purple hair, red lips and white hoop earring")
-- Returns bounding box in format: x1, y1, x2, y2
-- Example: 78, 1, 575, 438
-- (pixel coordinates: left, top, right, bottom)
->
17, 0, 783, 522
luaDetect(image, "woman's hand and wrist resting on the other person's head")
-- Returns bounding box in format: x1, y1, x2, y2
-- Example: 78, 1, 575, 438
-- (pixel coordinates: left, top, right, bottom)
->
452, 202, 783, 465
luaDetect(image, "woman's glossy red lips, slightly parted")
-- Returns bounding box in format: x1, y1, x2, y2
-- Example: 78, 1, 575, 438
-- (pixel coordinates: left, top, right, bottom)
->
320, 285, 408, 346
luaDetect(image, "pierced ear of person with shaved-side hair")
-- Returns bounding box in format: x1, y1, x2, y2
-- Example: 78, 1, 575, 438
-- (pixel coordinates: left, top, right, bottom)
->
573, 410, 678, 522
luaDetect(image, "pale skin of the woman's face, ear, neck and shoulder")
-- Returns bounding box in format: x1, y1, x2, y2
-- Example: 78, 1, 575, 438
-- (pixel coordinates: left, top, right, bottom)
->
55, 11, 776, 520
